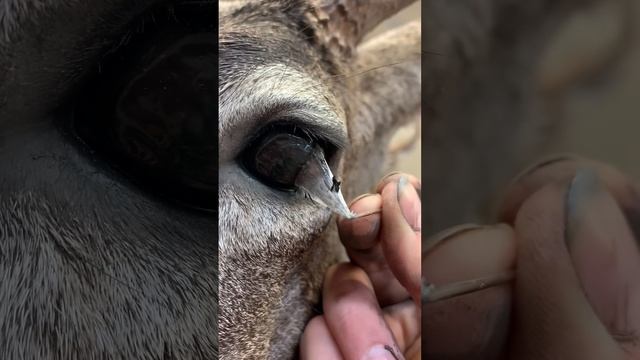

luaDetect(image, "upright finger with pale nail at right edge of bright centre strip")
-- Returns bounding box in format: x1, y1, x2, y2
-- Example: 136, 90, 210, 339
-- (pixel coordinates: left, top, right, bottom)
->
380, 177, 422, 306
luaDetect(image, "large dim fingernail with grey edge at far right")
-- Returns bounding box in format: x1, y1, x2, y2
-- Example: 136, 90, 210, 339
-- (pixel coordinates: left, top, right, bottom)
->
566, 170, 640, 333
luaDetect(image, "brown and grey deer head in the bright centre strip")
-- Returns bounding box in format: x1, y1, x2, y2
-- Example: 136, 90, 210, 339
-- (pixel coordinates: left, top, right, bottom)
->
218, 0, 421, 359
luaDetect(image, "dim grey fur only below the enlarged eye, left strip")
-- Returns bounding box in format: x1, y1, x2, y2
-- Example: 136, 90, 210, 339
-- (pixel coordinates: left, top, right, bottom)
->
0, 126, 217, 359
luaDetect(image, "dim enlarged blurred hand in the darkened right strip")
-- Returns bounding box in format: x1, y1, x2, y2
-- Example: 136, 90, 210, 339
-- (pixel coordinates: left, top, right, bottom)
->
422, 156, 640, 360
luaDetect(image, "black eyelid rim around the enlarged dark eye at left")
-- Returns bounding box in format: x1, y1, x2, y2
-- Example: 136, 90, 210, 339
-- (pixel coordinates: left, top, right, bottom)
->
55, 1, 217, 212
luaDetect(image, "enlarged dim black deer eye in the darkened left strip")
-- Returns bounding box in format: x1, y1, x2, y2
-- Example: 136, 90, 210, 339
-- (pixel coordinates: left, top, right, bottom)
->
72, 2, 218, 211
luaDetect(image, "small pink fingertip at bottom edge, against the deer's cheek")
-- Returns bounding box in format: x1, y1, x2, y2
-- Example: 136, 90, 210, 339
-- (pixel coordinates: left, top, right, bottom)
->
300, 316, 342, 360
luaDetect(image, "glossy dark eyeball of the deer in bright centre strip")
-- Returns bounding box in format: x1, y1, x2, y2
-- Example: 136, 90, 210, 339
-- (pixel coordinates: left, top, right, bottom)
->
254, 134, 313, 189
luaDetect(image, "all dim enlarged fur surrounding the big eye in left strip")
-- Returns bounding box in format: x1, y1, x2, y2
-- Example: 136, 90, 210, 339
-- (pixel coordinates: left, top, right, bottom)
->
0, 0, 217, 359
